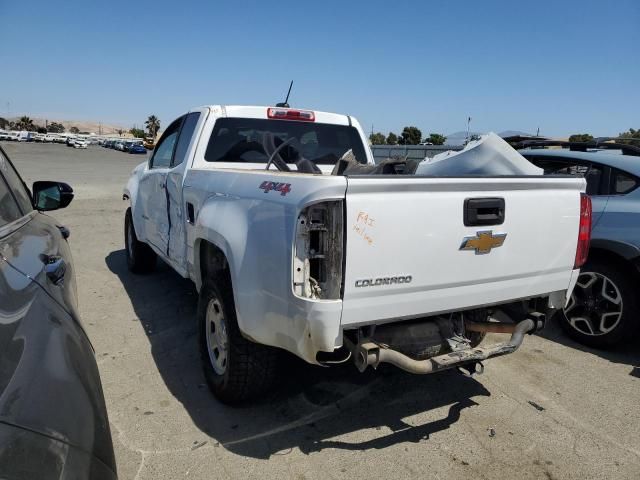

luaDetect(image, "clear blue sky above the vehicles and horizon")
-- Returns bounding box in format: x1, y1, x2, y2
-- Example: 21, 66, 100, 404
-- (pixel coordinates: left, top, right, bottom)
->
0, 0, 640, 136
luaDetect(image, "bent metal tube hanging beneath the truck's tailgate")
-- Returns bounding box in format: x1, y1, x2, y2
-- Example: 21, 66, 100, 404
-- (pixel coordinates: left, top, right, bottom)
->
349, 314, 544, 375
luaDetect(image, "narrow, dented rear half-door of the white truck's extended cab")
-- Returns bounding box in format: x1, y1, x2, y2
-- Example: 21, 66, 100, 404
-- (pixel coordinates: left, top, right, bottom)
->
166, 112, 205, 269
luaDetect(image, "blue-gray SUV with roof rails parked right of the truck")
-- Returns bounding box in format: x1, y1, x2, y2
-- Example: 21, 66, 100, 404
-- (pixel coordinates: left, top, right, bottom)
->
520, 141, 640, 348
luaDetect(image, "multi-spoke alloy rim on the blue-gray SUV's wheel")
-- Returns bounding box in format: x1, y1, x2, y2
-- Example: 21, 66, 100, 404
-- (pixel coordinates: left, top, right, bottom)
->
564, 272, 623, 337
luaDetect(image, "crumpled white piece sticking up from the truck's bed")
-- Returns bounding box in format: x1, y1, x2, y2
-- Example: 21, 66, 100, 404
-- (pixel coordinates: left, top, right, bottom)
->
415, 132, 543, 176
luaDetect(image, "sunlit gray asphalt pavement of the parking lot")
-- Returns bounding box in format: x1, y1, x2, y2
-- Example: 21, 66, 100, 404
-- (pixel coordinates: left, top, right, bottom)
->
3, 142, 640, 479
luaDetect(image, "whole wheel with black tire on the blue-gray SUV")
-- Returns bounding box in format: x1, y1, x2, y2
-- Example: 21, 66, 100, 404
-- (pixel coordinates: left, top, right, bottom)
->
560, 260, 640, 348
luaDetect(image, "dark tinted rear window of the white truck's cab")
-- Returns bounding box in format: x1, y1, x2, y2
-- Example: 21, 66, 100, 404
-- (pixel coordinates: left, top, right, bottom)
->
204, 118, 367, 165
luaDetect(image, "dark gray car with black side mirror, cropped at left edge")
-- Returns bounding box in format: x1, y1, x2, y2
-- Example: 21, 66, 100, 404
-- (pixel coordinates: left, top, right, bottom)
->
0, 144, 116, 480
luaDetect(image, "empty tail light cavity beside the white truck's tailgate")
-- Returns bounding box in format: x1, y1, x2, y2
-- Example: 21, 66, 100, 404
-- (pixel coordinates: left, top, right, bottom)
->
292, 201, 344, 300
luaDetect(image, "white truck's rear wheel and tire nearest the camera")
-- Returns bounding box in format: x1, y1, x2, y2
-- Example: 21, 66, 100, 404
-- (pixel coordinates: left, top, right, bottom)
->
197, 273, 279, 405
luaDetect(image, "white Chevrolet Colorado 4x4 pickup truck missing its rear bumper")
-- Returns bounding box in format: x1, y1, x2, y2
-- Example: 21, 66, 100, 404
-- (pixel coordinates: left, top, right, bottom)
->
123, 106, 591, 403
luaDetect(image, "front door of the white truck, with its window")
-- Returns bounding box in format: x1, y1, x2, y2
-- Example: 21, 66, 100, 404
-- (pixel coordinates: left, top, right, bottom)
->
138, 116, 184, 255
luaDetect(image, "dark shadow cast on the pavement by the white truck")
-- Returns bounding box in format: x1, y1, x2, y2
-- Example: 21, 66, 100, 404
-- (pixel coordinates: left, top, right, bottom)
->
105, 250, 490, 458
